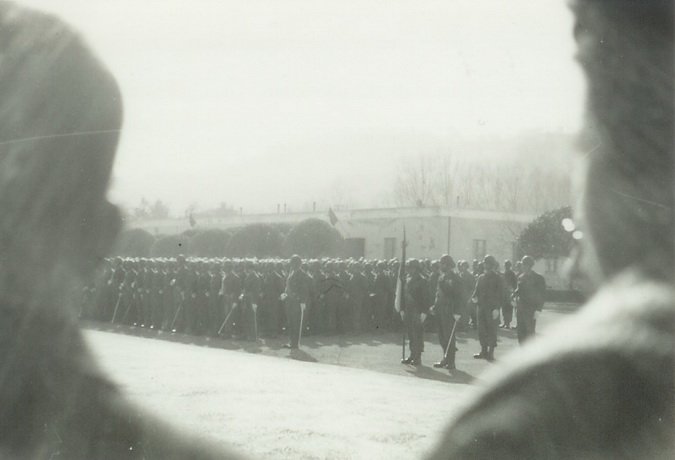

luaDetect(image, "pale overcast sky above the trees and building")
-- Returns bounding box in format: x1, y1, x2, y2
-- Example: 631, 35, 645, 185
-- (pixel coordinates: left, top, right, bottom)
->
23, 0, 584, 214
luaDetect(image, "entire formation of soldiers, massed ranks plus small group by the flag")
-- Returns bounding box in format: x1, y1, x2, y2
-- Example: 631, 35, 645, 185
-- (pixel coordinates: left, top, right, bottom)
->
80, 255, 543, 360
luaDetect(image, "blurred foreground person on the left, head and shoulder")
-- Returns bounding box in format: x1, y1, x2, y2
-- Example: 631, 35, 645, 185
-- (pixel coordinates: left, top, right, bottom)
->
0, 2, 240, 459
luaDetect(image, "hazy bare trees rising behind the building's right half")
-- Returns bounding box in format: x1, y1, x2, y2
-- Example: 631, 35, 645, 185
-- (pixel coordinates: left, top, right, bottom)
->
393, 136, 571, 214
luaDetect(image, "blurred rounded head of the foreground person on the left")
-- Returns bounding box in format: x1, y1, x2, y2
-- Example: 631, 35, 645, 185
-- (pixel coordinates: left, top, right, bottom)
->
0, 2, 122, 304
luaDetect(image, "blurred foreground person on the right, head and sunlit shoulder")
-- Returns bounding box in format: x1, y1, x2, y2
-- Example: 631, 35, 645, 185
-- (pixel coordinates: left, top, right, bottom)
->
430, 0, 675, 459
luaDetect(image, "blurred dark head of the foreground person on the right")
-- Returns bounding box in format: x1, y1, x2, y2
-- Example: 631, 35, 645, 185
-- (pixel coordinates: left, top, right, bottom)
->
573, 0, 675, 287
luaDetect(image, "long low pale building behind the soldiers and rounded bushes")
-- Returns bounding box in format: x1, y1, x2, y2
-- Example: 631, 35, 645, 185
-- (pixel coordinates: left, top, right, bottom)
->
127, 207, 535, 270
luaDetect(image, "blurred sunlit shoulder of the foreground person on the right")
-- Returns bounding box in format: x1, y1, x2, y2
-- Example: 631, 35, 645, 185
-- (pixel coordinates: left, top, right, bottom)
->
432, 273, 675, 458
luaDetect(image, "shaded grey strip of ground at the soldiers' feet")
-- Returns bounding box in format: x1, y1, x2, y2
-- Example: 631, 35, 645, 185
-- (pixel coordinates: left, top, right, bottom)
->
81, 308, 574, 384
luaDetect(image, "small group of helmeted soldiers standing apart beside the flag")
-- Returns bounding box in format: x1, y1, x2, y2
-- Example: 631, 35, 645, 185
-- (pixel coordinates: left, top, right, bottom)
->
396, 254, 546, 370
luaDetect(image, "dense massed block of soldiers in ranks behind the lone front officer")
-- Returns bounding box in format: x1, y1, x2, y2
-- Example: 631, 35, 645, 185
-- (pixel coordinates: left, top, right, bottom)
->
81, 256, 540, 346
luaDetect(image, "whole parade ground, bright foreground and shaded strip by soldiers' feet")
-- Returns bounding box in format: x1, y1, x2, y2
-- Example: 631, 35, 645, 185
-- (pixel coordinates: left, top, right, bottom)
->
85, 306, 571, 459
